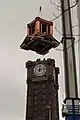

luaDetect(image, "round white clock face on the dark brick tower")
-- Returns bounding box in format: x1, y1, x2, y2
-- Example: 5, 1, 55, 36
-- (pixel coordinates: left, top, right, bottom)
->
34, 64, 46, 76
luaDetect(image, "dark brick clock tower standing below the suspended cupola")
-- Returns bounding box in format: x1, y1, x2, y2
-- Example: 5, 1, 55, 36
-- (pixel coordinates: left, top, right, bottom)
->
26, 58, 59, 120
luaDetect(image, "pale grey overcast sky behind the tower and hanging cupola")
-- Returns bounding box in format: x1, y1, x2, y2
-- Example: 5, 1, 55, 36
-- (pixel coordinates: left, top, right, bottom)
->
0, 0, 79, 120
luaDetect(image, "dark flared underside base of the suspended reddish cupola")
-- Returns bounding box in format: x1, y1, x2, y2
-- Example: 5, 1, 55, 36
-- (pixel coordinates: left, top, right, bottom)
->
20, 32, 60, 55
